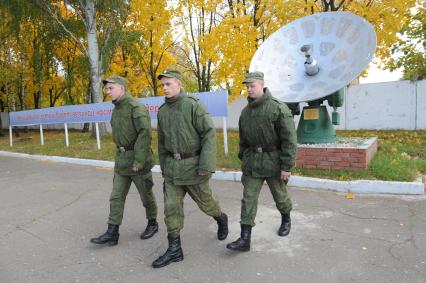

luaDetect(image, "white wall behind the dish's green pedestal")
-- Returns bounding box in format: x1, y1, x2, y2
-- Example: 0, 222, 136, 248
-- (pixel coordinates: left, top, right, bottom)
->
228, 80, 426, 130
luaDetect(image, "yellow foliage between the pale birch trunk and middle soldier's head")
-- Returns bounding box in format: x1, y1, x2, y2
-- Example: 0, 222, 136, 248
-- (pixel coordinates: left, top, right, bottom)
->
120, 0, 175, 96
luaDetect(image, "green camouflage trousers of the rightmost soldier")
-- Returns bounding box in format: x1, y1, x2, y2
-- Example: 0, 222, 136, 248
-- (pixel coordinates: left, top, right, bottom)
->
241, 175, 292, 226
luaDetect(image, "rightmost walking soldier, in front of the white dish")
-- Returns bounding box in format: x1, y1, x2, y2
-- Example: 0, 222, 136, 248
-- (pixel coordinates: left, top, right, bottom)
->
226, 72, 297, 251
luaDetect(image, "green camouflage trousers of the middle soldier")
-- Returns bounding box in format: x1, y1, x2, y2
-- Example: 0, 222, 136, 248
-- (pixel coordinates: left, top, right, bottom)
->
163, 180, 221, 236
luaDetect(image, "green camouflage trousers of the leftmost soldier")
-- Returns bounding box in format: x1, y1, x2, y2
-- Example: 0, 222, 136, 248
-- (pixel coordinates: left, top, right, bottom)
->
108, 172, 157, 225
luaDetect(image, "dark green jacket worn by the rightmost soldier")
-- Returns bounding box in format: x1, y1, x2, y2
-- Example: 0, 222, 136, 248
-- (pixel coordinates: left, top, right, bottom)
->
238, 88, 297, 177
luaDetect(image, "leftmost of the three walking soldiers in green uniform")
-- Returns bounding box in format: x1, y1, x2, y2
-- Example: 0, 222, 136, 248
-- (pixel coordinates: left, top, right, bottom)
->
90, 76, 158, 245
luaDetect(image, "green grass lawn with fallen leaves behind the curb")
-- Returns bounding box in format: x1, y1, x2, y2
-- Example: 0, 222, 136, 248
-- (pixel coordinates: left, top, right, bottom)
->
0, 131, 426, 181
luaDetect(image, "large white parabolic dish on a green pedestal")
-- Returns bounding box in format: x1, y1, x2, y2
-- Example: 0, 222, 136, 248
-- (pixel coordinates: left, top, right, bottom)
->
250, 12, 376, 102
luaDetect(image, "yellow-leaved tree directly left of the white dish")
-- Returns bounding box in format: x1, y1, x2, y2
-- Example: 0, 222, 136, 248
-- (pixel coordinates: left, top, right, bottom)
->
201, 0, 305, 101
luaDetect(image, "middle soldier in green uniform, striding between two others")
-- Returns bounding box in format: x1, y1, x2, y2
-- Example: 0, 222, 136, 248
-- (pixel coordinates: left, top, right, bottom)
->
152, 70, 228, 268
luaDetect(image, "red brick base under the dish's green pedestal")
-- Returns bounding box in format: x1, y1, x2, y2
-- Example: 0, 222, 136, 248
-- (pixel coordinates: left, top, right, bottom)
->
296, 138, 377, 169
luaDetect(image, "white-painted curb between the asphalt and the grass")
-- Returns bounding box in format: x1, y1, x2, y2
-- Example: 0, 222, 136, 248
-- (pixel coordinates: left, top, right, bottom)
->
0, 151, 426, 195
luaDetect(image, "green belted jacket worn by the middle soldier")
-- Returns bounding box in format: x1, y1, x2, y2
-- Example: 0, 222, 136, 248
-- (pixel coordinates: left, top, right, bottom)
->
158, 91, 216, 185
